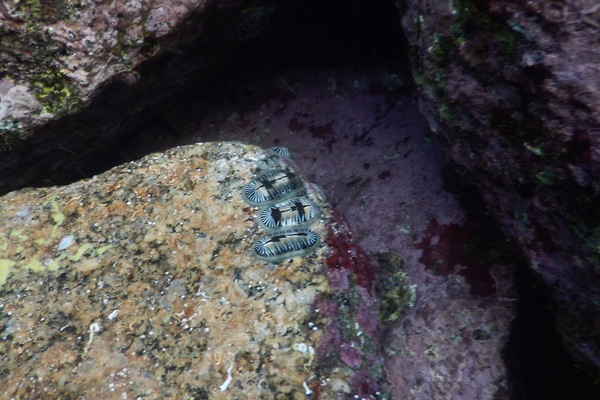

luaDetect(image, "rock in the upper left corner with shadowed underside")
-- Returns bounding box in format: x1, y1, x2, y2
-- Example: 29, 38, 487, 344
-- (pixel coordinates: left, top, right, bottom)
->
0, 0, 279, 192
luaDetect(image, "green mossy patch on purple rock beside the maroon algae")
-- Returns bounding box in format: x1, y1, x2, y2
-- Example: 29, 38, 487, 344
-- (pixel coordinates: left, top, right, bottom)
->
377, 252, 416, 324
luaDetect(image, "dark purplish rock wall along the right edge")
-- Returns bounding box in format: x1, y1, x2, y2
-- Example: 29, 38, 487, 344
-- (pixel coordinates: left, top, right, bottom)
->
402, 0, 600, 374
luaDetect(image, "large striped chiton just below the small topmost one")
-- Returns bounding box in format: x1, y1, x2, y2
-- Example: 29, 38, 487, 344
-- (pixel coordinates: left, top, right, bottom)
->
242, 169, 305, 206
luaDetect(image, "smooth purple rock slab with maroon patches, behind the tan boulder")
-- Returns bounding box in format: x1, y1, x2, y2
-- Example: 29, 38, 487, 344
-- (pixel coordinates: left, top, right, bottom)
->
158, 63, 517, 400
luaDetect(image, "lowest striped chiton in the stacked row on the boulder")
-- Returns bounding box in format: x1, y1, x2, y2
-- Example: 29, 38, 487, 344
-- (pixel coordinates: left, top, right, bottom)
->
252, 229, 320, 263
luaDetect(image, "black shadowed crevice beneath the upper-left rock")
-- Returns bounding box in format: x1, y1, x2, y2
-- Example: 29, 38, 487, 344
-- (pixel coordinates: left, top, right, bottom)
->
0, 0, 408, 194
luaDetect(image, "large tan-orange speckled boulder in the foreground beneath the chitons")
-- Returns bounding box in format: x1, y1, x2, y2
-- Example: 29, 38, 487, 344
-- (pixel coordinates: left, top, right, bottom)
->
0, 143, 383, 399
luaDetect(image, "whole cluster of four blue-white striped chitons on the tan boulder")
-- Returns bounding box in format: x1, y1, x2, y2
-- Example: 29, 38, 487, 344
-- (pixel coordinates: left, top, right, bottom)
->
242, 147, 321, 262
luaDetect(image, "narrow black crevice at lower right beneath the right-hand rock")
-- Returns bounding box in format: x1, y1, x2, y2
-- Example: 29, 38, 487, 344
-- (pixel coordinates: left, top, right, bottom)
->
444, 164, 600, 400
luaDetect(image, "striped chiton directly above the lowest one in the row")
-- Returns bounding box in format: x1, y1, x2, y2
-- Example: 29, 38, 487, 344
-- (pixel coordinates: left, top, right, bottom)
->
258, 197, 321, 231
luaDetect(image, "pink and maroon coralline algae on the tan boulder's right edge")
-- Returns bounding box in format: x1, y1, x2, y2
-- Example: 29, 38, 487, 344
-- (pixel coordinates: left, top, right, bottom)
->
315, 209, 383, 399
